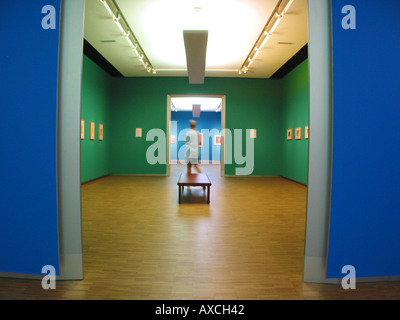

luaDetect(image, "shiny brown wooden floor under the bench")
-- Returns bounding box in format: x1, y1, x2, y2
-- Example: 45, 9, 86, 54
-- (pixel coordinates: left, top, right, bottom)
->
0, 165, 400, 300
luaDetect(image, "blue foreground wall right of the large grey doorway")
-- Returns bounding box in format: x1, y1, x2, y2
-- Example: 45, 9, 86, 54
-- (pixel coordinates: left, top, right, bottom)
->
327, 0, 400, 278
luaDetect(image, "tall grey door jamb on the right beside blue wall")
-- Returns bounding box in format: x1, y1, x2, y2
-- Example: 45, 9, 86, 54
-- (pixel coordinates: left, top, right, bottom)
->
304, 0, 337, 283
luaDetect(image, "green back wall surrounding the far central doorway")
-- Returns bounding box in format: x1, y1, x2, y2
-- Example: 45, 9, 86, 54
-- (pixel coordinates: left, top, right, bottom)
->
111, 77, 282, 175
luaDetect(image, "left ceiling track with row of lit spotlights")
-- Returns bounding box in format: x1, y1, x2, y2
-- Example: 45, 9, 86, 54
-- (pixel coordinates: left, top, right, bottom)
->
99, 0, 157, 74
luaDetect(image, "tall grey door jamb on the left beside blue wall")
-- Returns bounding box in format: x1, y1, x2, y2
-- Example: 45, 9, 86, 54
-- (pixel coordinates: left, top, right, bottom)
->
57, 0, 85, 280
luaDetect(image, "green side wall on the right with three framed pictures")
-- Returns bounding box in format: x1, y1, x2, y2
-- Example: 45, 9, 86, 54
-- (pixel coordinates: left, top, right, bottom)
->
281, 60, 309, 184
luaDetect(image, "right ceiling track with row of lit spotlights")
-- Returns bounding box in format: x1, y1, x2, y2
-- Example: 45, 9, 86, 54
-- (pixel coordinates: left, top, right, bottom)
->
239, 0, 294, 74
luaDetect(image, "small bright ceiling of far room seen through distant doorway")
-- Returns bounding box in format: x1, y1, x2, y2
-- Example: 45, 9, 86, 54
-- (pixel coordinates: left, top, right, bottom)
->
171, 97, 222, 112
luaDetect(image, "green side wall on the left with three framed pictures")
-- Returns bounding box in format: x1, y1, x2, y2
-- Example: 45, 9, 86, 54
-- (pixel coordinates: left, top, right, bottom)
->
81, 56, 112, 182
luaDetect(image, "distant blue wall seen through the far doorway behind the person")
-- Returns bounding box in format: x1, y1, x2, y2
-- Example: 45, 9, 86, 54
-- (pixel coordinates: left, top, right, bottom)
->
171, 111, 221, 161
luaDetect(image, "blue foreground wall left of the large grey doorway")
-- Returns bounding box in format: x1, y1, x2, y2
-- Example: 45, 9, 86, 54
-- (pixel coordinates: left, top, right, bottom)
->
0, 0, 60, 274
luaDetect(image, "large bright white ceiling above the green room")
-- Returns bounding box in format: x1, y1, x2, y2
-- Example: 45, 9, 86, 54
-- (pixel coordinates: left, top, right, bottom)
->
84, 0, 308, 78
